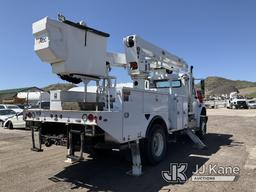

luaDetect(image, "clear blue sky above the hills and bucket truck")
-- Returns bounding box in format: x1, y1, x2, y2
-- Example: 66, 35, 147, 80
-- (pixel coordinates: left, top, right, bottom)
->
0, 0, 256, 89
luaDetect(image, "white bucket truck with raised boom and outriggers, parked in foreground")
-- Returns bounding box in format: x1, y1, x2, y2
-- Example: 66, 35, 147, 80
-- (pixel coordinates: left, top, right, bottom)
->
24, 15, 207, 175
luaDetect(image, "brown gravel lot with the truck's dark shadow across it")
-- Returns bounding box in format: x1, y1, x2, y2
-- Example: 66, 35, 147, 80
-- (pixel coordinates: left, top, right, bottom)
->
0, 109, 256, 192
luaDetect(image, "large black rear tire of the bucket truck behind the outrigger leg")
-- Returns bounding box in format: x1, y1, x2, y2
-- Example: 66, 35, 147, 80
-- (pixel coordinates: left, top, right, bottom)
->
142, 124, 167, 165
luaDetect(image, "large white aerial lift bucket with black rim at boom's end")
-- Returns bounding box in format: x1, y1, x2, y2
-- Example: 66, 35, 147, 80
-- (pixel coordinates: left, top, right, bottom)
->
33, 17, 109, 77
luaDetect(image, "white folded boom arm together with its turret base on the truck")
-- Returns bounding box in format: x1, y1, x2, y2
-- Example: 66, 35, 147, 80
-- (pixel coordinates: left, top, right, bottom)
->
124, 35, 188, 89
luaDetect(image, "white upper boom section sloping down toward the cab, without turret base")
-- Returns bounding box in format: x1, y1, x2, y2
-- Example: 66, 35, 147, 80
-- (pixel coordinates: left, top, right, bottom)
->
124, 35, 188, 75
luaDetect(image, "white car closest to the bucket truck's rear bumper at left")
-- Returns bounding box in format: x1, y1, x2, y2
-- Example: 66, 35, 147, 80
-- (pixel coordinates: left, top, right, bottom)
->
3, 112, 26, 129
